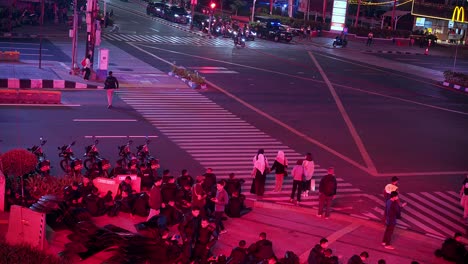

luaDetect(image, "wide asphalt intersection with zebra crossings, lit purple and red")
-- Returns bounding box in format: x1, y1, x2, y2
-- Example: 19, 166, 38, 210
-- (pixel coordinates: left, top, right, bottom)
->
0, 0, 468, 251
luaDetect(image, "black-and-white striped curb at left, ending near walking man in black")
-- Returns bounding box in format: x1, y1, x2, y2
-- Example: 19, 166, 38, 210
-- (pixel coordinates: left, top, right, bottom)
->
0, 78, 104, 89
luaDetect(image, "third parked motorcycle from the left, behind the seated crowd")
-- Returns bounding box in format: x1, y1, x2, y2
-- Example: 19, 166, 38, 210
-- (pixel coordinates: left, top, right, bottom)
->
84, 139, 110, 178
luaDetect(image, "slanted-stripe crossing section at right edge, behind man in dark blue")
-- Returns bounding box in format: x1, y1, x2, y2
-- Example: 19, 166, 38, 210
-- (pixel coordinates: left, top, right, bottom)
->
368, 191, 467, 237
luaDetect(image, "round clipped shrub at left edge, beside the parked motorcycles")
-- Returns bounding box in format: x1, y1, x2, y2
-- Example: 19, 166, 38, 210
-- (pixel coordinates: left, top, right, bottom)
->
0, 149, 37, 177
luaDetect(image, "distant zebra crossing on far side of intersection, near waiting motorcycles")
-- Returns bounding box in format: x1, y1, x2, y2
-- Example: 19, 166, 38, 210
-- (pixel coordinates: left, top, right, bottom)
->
102, 33, 295, 48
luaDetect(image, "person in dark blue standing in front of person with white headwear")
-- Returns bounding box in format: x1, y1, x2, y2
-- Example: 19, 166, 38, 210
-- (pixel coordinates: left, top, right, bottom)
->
382, 191, 401, 249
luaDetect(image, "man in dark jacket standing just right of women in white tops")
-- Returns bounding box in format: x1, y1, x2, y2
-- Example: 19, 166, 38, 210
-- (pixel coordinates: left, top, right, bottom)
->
317, 167, 337, 219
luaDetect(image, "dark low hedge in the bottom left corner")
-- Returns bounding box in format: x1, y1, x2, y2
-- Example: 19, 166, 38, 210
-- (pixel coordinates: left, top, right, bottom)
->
0, 242, 71, 264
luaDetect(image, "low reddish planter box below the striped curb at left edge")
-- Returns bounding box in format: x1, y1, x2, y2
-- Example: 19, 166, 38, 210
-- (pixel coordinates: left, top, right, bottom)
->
0, 89, 62, 104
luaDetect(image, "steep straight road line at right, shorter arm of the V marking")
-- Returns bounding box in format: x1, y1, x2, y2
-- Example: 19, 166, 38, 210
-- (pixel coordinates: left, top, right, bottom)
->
308, 51, 377, 174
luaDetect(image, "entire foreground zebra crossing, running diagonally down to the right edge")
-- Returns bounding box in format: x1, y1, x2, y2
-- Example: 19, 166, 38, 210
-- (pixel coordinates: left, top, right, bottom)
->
117, 88, 465, 237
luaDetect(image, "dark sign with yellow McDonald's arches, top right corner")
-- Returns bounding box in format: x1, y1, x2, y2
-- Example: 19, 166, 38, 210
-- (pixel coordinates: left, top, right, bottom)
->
411, 0, 468, 23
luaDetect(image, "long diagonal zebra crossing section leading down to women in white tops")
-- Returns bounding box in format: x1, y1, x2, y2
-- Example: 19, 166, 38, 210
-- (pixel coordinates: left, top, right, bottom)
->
118, 89, 362, 203
